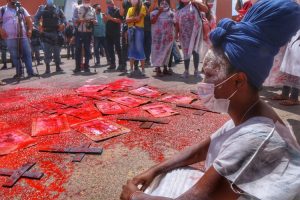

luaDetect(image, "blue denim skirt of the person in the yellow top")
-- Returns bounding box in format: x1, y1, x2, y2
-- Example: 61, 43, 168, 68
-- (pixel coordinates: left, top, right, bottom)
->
128, 27, 146, 60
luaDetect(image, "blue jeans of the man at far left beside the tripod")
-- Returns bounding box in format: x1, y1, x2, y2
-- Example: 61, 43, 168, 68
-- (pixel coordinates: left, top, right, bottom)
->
6, 38, 33, 76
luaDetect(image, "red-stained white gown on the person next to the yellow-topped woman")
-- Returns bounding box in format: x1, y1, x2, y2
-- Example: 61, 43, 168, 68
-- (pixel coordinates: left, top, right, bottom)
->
150, 9, 175, 67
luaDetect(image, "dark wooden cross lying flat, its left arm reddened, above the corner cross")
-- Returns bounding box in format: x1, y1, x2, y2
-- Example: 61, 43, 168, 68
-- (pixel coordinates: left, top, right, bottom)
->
39, 143, 103, 162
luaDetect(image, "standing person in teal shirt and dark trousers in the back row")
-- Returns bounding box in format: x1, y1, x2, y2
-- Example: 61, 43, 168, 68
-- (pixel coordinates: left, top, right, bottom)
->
93, 4, 109, 66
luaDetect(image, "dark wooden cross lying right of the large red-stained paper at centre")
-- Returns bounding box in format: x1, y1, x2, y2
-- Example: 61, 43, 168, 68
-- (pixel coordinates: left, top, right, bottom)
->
117, 116, 170, 129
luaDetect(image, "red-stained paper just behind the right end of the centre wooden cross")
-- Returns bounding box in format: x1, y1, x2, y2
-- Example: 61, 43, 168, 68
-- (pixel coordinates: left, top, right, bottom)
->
143, 104, 179, 117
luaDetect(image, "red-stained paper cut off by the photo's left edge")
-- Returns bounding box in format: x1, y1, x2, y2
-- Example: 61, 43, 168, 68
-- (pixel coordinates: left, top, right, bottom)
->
0, 130, 36, 155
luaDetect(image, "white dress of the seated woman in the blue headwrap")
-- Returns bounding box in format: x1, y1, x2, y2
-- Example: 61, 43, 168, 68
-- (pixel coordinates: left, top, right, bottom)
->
146, 117, 300, 200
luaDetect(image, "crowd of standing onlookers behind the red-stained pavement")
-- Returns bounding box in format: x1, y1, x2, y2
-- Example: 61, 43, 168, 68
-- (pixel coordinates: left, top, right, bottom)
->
0, 0, 300, 105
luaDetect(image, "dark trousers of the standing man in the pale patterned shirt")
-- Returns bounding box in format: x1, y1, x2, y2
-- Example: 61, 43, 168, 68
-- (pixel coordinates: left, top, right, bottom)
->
75, 32, 92, 69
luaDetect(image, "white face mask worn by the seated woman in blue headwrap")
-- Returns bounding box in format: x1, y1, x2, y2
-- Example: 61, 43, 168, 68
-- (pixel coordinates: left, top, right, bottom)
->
198, 74, 237, 113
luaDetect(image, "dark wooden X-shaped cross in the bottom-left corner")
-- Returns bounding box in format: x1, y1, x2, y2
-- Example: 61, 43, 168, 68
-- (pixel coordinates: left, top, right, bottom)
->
0, 163, 44, 188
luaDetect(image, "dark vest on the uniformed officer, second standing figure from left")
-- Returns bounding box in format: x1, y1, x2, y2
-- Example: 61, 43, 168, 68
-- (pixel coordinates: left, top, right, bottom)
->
42, 6, 60, 32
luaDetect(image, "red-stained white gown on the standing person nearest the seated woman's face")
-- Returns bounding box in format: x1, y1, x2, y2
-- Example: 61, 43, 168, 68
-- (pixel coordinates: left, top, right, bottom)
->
176, 3, 203, 60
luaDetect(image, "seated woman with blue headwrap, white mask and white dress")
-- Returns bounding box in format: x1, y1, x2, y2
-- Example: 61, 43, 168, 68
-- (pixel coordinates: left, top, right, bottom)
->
121, 0, 300, 200
